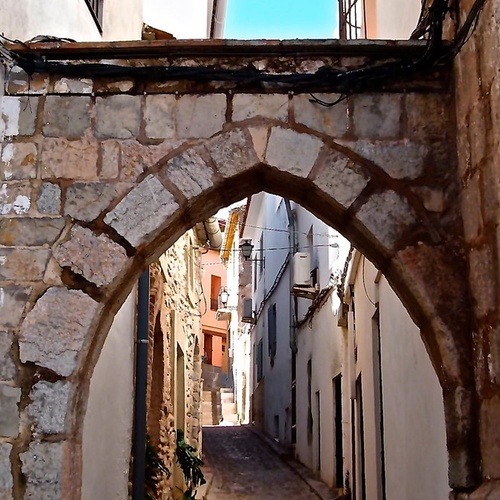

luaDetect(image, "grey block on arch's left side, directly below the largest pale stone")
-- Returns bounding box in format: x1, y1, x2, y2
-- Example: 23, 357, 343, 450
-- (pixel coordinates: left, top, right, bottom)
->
27, 381, 71, 434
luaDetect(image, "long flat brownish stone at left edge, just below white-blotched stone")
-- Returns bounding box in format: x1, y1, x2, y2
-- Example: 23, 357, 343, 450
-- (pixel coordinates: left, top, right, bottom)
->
0, 217, 65, 246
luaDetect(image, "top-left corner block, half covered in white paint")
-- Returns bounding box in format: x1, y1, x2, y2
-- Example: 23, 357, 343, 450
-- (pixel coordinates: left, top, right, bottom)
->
0, 96, 39, 137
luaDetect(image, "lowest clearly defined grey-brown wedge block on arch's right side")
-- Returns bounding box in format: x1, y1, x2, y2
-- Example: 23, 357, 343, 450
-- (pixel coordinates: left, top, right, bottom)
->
356, 191, 417, 249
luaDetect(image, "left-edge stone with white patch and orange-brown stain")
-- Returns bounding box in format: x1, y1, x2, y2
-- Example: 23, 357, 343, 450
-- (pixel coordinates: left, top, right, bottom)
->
0, 142, 37, 181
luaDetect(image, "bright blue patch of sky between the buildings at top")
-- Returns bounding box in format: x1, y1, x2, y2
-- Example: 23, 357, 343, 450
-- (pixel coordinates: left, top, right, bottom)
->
224, 0, 338, 40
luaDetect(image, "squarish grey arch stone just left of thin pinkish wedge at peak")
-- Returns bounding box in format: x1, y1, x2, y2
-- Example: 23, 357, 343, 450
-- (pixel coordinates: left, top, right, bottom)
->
207, 130, 258, 177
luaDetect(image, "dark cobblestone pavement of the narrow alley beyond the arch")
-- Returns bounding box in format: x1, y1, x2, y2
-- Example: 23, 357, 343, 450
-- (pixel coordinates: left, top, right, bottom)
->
203, 426, 318, 500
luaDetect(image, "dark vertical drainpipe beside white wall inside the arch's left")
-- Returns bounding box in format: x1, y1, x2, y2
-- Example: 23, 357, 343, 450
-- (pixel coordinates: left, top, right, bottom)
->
132, 267, 149, 500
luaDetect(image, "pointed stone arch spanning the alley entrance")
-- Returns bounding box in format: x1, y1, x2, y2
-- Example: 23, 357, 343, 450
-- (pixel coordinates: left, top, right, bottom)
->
9, 113, 477, 492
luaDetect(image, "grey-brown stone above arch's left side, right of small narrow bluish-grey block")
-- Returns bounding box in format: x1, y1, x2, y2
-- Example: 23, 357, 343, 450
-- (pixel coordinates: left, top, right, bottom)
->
64, 182, 118, 222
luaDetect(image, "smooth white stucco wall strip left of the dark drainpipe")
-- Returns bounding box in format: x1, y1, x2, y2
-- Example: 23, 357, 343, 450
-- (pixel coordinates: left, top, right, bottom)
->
82, 289, 136, 500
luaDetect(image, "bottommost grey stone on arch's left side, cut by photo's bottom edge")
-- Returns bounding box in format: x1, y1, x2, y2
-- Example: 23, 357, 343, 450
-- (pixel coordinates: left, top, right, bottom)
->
20, 441, 64, 500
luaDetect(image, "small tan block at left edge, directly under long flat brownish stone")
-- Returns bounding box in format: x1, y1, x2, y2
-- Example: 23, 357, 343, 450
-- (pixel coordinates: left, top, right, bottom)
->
0, 247, 50, 281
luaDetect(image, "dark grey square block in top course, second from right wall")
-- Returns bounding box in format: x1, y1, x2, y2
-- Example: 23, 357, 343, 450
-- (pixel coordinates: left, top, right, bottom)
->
351, 94, 402, 139
